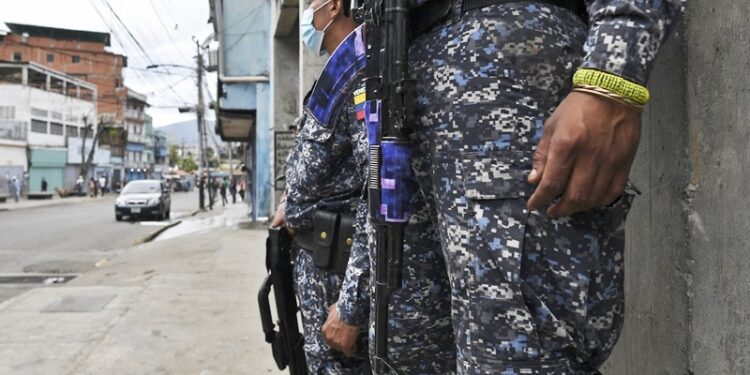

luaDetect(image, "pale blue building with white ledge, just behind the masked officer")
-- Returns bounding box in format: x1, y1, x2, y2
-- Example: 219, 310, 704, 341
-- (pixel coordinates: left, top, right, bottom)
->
209, 0, 274, 220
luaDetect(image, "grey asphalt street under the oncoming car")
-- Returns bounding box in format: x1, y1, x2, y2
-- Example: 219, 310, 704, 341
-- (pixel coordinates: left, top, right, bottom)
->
0, 192, 204, 302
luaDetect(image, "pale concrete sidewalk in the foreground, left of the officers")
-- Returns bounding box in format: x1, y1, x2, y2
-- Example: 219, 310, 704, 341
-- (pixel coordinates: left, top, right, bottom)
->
0, 205, 282, 375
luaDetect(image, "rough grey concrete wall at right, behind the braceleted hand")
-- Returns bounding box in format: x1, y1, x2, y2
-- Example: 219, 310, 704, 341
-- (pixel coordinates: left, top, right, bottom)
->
603, 0, 750, 375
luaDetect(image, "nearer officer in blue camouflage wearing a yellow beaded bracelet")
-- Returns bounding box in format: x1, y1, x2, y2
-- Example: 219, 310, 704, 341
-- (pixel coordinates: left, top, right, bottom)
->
400, 0, 685, 375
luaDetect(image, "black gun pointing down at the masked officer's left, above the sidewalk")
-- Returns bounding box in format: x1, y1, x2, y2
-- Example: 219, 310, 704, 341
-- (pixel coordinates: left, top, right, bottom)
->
258, 228, 307, 375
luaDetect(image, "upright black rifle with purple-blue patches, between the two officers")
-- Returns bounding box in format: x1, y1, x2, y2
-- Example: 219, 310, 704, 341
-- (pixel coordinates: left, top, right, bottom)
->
363, 0, 414, 374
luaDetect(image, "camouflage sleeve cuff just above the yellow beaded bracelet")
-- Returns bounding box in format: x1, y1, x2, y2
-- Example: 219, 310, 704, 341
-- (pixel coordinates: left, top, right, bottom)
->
582, 0, 687, 85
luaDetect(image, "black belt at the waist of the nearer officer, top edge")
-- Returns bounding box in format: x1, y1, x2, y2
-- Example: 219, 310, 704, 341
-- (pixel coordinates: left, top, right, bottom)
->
409, 0, 588, 39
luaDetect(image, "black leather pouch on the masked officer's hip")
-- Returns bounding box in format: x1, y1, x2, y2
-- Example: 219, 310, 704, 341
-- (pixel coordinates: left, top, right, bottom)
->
294, 211, 354, 275
